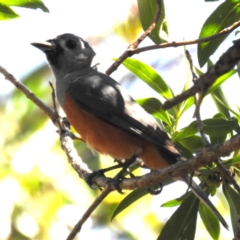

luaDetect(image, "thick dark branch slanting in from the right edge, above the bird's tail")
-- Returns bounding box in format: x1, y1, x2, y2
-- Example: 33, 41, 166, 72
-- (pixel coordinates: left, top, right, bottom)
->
163, 39, 240, 109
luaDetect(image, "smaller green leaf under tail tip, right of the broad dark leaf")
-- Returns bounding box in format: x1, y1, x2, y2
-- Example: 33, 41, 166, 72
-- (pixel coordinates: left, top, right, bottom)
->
199, 202, 220, 240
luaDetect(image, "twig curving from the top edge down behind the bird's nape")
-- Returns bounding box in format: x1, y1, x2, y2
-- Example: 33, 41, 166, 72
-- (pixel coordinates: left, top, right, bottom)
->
106, 0, 161, 75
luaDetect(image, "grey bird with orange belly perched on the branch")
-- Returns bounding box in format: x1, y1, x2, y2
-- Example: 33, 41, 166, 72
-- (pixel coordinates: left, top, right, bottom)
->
31, 33, 228, 229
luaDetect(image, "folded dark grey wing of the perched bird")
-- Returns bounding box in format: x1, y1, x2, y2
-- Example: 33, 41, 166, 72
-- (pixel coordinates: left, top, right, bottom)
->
67, 71, 179, 164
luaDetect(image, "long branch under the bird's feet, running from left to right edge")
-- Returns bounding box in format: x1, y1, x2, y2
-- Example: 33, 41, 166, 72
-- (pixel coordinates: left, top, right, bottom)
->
0, 67, 240, 190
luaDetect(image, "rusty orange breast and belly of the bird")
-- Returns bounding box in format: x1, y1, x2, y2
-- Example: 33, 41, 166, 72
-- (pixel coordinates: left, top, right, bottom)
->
64, 96, 167, 169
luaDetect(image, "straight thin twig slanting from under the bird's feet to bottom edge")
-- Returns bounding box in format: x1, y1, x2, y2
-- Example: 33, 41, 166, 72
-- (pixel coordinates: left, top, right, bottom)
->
66, 185, 113, 240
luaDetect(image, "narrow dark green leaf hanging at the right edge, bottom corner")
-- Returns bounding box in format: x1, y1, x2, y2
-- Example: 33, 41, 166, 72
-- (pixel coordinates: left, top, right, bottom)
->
223, 181, 240, 233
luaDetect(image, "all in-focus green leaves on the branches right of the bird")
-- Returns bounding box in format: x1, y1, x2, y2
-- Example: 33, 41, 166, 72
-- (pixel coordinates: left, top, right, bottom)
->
112, 0, 240, 240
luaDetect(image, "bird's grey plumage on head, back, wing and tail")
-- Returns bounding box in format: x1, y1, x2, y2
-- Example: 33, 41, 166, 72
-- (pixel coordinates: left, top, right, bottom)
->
33, 34, 228, 228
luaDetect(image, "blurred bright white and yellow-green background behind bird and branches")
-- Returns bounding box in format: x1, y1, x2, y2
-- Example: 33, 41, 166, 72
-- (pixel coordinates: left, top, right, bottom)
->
0, 0, 237, 240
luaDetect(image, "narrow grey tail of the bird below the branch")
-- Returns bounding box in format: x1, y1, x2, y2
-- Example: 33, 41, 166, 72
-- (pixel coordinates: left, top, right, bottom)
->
182, 175, 228, 229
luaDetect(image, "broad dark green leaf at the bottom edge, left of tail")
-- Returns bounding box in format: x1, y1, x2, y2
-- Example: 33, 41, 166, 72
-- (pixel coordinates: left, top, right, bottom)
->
157, 193, 199, 240
